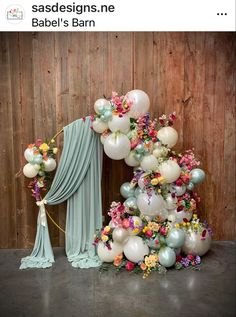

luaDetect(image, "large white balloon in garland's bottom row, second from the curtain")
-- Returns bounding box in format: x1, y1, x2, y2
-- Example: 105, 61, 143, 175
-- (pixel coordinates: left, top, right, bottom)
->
124, 236, 149, 263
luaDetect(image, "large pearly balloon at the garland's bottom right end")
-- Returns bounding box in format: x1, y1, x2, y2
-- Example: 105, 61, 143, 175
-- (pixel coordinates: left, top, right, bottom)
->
182, 229, 211, 256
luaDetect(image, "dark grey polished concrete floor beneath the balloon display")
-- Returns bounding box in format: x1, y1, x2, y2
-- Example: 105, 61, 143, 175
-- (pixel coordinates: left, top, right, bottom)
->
0, 242, 236, 317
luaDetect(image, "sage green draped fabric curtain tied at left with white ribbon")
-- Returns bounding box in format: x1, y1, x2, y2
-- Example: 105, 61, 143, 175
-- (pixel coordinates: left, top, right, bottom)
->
20, 117, 103, 269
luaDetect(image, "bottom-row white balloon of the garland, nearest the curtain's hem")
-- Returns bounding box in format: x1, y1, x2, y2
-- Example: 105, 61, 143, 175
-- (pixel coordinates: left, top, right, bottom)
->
97, 242, 124, 262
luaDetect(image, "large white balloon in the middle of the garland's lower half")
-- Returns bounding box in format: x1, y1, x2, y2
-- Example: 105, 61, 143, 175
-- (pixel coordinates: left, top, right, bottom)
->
137, 193, 165, 216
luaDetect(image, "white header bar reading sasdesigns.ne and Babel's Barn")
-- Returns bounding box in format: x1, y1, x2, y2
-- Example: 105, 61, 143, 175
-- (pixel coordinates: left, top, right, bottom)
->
0, 0, 236, 31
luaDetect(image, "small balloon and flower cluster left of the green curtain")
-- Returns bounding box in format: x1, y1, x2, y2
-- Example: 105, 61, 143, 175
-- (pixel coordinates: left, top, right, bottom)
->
23, 139, 58, 200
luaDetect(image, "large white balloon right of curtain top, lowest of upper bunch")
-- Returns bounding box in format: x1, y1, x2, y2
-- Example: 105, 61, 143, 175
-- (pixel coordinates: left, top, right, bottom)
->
104, 133, 131, 160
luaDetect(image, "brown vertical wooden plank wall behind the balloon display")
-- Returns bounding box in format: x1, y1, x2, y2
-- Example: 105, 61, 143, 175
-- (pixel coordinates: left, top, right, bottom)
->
0, 33, 236, 248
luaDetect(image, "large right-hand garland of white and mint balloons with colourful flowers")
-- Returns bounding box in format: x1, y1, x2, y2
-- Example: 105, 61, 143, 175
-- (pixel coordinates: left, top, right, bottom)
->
92, 90, 211, 274
